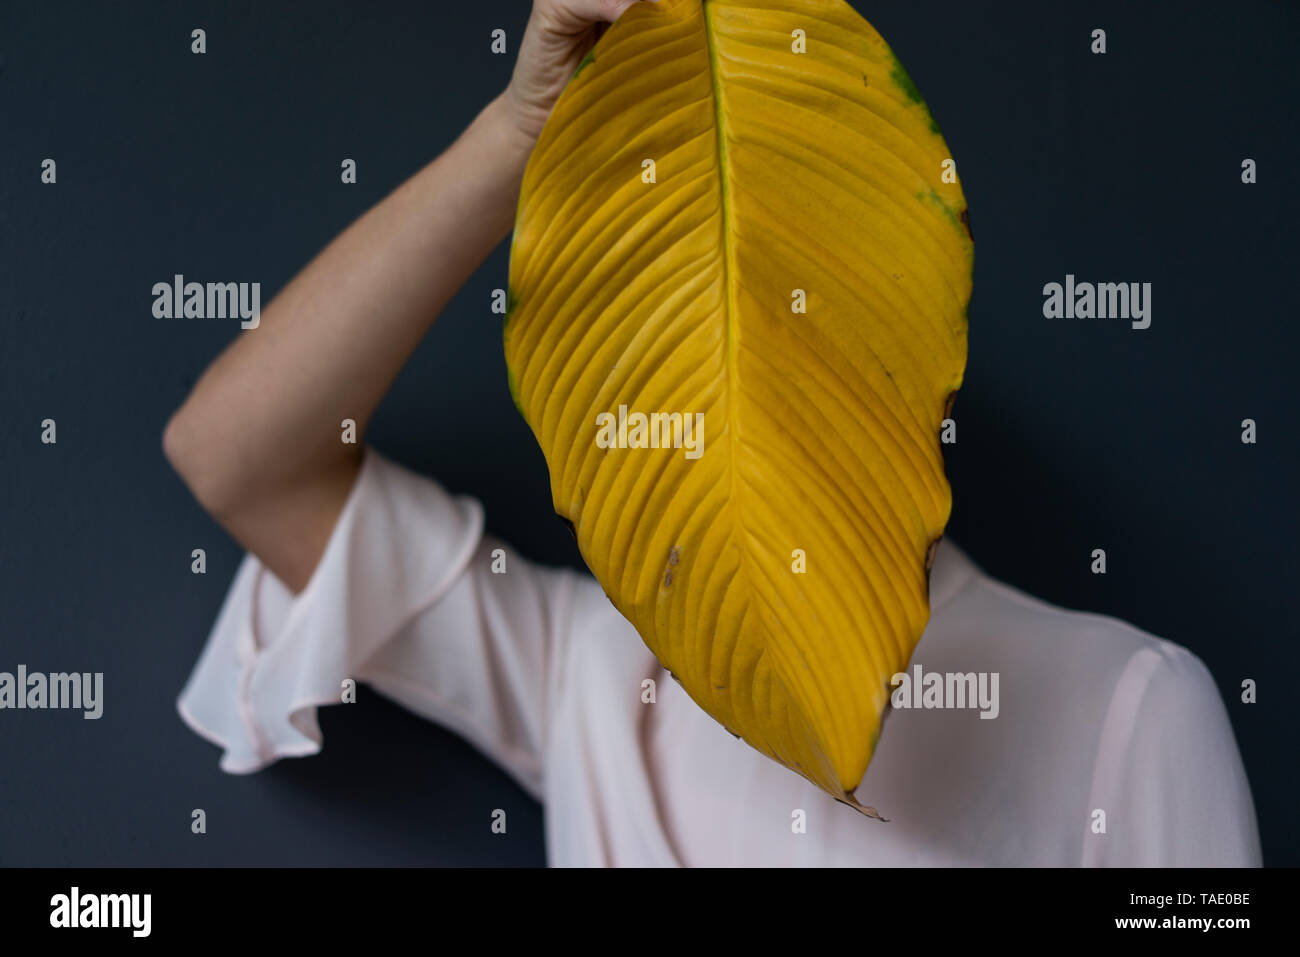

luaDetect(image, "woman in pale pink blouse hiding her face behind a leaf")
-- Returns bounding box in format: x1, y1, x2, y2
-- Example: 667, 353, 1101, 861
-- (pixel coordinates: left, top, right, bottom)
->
164, 0, 1260, 866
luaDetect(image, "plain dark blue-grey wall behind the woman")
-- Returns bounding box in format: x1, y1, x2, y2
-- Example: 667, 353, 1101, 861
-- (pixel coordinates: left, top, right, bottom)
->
0, 0, 1300, 865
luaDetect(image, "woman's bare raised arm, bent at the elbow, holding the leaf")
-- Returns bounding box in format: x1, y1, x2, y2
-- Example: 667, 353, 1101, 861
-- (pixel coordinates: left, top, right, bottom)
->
163, 0, 650, 592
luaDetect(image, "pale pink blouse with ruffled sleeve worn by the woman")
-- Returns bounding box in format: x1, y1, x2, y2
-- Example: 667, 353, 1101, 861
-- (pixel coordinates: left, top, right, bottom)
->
177, 447, 1261, 866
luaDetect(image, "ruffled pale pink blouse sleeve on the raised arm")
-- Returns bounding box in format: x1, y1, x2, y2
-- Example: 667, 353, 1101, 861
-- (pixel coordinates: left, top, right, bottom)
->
177, 447, 575, 793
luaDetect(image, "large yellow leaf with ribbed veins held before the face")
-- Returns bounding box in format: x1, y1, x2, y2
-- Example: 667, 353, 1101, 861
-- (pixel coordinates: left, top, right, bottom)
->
504, 0, 974, 813
